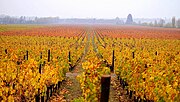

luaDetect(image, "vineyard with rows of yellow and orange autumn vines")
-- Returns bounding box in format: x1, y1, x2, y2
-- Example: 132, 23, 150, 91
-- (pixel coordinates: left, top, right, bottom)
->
0, 25, 180, 102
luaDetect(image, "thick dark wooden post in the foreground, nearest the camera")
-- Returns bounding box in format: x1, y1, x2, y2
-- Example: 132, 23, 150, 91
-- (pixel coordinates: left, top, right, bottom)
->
100, 75, 111, 102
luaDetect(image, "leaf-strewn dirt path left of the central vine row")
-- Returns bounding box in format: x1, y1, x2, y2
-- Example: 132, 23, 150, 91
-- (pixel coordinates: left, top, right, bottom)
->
51, 32, 90, 102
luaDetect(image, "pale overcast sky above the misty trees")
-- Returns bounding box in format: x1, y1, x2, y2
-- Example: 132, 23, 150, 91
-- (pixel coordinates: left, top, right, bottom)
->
0, 0, 180, 18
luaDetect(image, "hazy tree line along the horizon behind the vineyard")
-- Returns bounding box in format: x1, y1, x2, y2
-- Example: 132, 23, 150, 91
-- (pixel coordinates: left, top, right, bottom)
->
0, 14, 180, 28
